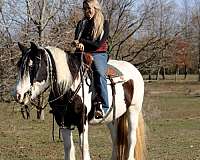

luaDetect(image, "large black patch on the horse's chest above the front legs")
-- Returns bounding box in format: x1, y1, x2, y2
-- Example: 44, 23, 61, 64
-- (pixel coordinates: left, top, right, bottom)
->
49, 90, 87, 133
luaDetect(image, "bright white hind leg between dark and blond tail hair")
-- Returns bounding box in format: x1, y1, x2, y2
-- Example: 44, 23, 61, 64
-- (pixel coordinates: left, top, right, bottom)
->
128, 106, 139, 160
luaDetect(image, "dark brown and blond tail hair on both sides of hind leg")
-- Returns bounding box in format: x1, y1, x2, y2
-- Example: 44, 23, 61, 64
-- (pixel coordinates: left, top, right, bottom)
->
117, 113, 146, 160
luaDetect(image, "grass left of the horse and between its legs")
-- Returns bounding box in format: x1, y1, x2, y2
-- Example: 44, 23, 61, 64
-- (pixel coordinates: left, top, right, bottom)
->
0, 103, 111, 160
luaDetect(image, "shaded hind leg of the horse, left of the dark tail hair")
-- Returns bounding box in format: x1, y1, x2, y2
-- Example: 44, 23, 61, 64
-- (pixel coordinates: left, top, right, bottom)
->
107, 120, 117, 160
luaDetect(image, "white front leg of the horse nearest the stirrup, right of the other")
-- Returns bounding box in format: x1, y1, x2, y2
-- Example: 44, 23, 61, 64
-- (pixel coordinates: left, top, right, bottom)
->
79, 121, 91, 160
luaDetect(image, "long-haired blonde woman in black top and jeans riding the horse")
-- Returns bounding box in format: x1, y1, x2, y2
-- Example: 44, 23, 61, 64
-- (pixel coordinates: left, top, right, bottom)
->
73, 0, 109, 118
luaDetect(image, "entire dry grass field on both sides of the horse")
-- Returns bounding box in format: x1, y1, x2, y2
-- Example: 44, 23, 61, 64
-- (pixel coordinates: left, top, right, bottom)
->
0, 75, 200, 160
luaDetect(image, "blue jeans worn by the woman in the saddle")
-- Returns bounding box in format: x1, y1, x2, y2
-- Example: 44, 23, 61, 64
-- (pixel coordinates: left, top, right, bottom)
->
92, 53, 109, 113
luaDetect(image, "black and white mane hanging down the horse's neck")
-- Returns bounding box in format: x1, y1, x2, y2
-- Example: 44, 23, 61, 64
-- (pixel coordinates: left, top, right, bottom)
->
46, 46, 80, 95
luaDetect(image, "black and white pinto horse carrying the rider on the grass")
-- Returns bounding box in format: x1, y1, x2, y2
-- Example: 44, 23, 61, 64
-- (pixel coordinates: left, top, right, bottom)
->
15, 42, 145, 160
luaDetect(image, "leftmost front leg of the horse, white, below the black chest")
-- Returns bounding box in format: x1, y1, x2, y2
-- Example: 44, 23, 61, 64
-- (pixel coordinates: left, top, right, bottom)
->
61, 129, 75, 160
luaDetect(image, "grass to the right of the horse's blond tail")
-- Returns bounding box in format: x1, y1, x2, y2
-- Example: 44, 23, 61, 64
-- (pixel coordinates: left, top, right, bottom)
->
144, 82, 200, 160
